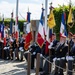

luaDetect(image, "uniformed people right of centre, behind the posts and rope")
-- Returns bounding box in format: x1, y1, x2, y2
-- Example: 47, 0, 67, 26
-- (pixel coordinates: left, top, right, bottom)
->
24, 32, 75, 75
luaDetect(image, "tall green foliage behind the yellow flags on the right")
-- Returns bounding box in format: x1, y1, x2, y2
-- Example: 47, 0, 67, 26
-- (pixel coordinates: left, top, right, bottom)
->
53, 6, 75, 39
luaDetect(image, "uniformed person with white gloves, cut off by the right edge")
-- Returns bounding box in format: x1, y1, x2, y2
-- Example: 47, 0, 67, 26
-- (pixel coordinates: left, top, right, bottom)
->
66, 34, 75, 75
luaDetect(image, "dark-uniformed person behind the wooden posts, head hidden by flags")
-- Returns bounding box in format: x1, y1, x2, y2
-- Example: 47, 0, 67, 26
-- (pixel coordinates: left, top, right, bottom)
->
24, 42, 41, 69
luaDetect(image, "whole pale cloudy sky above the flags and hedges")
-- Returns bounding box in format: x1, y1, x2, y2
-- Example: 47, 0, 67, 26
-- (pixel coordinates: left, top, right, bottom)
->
0, 0, 75, 20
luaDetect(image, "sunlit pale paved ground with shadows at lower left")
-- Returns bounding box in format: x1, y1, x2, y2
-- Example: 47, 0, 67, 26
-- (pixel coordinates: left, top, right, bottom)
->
0, 59, 35, 75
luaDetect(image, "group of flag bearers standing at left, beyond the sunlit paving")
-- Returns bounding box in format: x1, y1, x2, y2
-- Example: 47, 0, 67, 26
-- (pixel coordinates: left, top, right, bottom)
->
0, 34, 25, 61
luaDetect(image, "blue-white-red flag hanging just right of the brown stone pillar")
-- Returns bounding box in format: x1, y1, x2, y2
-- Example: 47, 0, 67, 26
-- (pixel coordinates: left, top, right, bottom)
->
36, 8, 45, 48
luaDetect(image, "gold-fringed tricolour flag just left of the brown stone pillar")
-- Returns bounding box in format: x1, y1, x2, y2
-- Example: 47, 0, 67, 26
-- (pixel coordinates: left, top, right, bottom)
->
25, 12, 32, 50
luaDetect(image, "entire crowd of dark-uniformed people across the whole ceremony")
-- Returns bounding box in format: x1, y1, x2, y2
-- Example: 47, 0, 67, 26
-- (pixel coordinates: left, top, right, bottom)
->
0, 32, 75, 75
